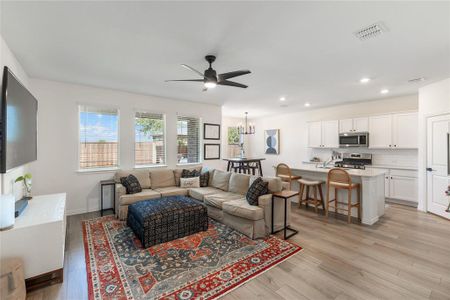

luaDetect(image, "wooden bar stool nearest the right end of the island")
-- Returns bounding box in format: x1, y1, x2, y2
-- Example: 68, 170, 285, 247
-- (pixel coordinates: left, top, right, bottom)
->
325, 168, 361, 223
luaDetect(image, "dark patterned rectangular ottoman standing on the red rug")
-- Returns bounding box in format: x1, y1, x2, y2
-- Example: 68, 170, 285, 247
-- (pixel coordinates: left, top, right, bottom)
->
127, 196, 208, 248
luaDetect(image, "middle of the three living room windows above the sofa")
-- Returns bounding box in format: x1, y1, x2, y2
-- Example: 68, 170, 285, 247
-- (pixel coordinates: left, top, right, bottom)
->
134, 112, 166, 166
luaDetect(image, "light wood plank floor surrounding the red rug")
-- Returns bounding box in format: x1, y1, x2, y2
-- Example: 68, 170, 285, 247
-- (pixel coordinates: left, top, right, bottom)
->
28, 204, 450, 300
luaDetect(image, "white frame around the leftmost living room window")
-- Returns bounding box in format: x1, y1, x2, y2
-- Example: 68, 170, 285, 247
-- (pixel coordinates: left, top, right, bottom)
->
76, 102, 121, 173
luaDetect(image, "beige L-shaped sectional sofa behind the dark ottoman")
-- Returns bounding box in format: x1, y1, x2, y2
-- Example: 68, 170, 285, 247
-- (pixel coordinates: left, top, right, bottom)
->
114, 167, 290, 238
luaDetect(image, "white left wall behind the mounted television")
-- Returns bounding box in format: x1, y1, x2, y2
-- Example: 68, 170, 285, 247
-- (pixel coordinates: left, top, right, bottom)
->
0, 36, 29, 200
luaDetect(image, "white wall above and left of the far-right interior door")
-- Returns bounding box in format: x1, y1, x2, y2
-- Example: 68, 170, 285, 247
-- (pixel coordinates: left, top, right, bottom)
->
418, 78, 450, 211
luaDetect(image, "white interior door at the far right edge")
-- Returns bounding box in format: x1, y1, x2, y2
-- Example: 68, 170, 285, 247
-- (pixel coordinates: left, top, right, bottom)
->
427, 115, 450, 219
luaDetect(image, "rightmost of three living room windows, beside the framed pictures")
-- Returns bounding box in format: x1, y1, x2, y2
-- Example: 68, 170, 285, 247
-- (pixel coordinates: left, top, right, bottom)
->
177, 116, 200, 164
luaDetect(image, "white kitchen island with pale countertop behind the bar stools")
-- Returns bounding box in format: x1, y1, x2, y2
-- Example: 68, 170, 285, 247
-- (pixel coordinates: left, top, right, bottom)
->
291, 163, 386, 225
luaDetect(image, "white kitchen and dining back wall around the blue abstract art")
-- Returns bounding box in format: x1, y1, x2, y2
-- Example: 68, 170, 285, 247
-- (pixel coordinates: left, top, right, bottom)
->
249, 95, 418, 175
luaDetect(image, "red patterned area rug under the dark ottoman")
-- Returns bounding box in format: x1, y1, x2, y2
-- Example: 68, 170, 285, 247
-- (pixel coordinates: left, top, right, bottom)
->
83, 216, 302, 299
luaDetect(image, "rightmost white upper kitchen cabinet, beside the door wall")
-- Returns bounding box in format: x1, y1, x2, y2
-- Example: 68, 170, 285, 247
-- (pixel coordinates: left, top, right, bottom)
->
392, 113, 419, 149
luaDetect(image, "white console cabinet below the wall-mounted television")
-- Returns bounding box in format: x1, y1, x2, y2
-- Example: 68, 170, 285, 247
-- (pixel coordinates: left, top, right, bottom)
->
0, 193, 66, 288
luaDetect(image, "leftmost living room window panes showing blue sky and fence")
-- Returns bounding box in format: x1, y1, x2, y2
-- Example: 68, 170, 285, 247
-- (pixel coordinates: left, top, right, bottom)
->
79, 105, 119, 170
